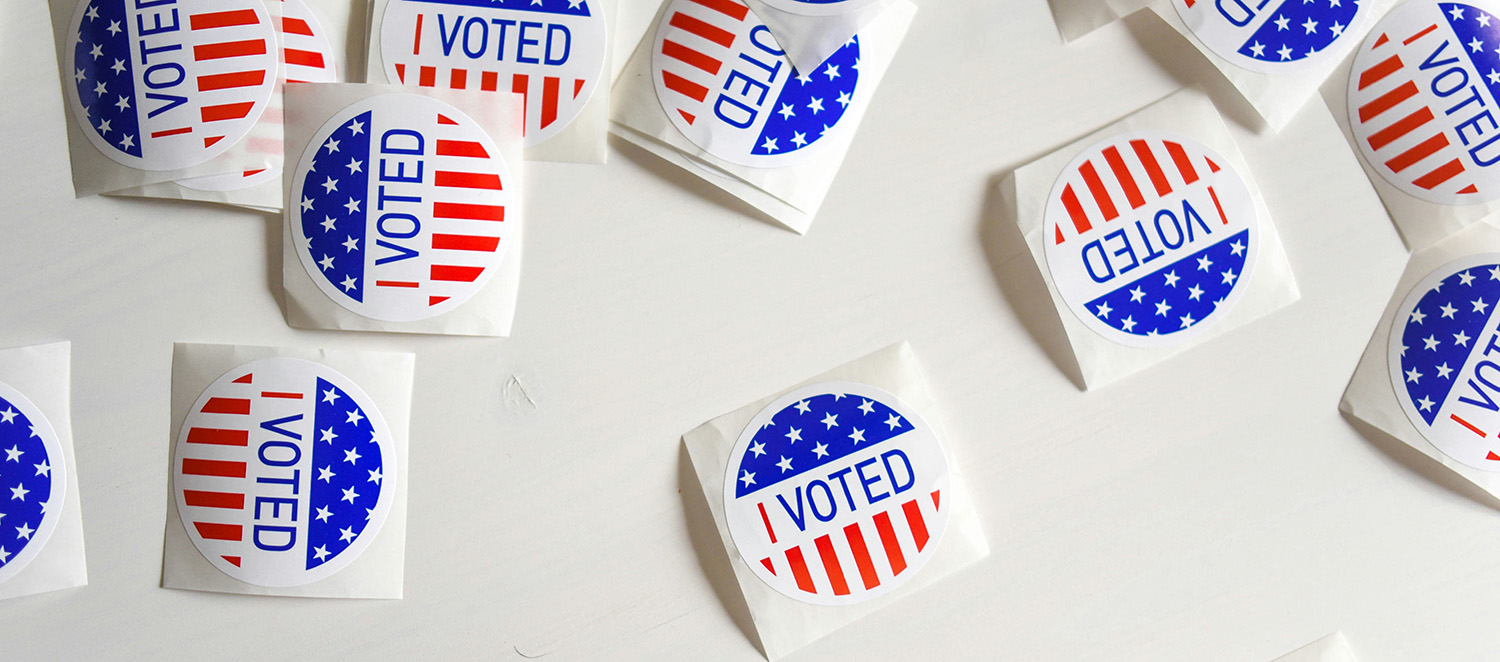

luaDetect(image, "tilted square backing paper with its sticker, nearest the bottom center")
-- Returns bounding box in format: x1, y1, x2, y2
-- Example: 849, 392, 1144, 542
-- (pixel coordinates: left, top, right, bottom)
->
683, 344, 989, 659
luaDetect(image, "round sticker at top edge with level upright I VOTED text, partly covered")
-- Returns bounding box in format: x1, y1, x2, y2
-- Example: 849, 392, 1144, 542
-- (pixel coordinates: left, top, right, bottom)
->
381, 0, 609, 146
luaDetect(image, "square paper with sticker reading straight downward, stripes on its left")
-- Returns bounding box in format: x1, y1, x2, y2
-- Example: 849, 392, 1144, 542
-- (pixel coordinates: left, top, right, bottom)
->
162, 345, 413, 597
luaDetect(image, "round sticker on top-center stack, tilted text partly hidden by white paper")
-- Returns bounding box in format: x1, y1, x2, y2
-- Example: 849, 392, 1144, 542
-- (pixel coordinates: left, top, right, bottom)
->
651, 0, 863, 168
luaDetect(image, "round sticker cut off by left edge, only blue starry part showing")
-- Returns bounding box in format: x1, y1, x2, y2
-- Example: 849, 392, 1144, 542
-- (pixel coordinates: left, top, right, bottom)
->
0, 383, 68, 582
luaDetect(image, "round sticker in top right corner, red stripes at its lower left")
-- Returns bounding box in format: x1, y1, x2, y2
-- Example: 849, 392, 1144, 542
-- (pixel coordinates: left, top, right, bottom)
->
1349, 0, 1500, 204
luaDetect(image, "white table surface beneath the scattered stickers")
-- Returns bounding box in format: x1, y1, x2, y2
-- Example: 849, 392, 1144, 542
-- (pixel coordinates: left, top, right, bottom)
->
0, 0, 1500, 660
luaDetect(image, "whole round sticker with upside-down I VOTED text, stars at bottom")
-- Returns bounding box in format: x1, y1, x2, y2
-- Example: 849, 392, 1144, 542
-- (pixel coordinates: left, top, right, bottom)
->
1044, 131, 1260, 347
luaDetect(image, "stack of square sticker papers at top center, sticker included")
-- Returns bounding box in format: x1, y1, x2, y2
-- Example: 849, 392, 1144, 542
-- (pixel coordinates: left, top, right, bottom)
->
611, 0, 917, 233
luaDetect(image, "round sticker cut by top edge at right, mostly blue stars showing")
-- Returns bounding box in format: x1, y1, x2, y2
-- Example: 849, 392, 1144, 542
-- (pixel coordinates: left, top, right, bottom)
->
1172, 0, 1370, 74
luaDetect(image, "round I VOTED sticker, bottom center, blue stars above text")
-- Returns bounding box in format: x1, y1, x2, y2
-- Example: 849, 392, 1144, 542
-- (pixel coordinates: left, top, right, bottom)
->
725, 381, 951, 605
